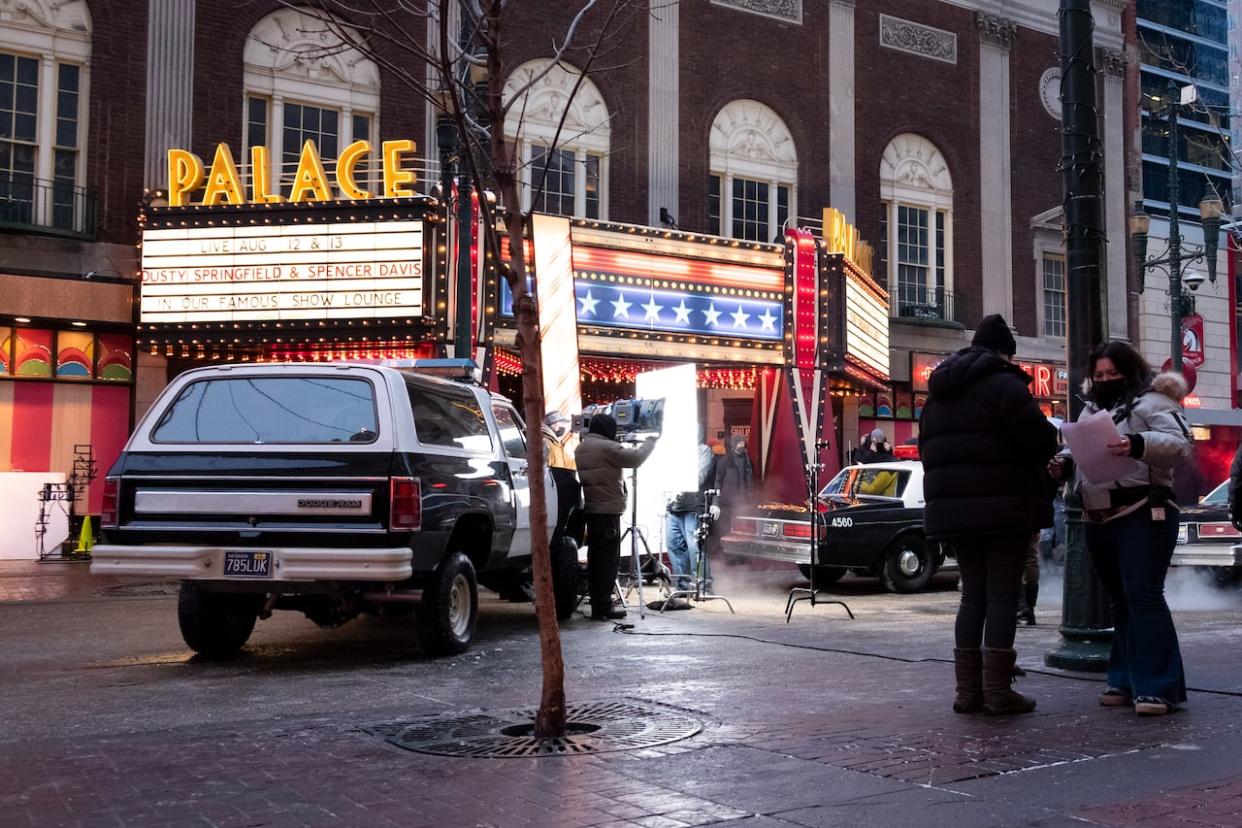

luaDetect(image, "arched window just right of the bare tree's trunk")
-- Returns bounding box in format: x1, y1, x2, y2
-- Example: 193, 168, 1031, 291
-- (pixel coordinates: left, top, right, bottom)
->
504, 60, 611, 218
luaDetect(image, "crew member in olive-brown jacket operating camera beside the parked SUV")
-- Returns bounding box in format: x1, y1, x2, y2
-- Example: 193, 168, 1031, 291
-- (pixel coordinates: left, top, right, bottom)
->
576, 413, 657, 621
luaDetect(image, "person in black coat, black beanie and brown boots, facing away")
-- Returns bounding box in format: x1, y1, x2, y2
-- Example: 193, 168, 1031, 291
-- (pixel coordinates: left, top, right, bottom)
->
919, 315, 1057, 714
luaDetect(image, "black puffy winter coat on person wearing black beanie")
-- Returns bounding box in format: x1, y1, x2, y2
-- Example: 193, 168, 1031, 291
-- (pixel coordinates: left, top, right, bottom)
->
919, 348, 1057, 540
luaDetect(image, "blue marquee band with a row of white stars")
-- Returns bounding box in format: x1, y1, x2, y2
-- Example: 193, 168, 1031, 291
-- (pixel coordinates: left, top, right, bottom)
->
501, 279, 785, 341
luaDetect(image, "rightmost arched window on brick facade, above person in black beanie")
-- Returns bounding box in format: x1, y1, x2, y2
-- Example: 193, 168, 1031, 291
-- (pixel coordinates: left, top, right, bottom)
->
877, 133, 954, 322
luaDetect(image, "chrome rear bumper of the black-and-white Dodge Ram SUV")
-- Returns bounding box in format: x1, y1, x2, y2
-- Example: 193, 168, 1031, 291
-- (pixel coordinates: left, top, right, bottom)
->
91, 544, 414, 583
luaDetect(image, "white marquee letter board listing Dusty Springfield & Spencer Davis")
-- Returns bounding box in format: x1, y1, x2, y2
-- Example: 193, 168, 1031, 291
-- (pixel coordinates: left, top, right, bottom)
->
140, 221, 424, 323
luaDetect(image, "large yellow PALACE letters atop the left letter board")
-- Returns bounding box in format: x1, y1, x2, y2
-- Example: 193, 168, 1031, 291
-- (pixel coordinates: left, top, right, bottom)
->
168, 139, 417, 207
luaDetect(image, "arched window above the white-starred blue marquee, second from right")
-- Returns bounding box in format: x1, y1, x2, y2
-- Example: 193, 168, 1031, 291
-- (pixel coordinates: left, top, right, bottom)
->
708, 101, 797, 242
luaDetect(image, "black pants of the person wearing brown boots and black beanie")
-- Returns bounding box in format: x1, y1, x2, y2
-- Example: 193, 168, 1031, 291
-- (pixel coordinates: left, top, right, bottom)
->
953, 533, 1031, 649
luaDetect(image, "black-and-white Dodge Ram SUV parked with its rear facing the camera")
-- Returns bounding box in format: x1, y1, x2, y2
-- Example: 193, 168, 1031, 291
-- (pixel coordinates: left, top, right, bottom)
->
91, 364, 578, 655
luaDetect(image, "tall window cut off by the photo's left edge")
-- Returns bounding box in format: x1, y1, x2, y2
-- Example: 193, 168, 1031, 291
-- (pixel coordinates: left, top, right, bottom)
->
0, 0, 91, 232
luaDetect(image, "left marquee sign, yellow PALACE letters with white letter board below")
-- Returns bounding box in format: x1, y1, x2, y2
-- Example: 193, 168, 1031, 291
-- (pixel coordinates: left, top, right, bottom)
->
140, 142, 428, 324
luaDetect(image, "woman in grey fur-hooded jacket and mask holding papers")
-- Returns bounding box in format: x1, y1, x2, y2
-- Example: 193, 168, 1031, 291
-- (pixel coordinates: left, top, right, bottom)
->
1048, 341, 1194, 716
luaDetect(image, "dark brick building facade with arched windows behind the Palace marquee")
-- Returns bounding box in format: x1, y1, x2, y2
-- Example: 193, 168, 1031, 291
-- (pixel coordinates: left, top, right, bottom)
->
0, 0, 1129, 523
